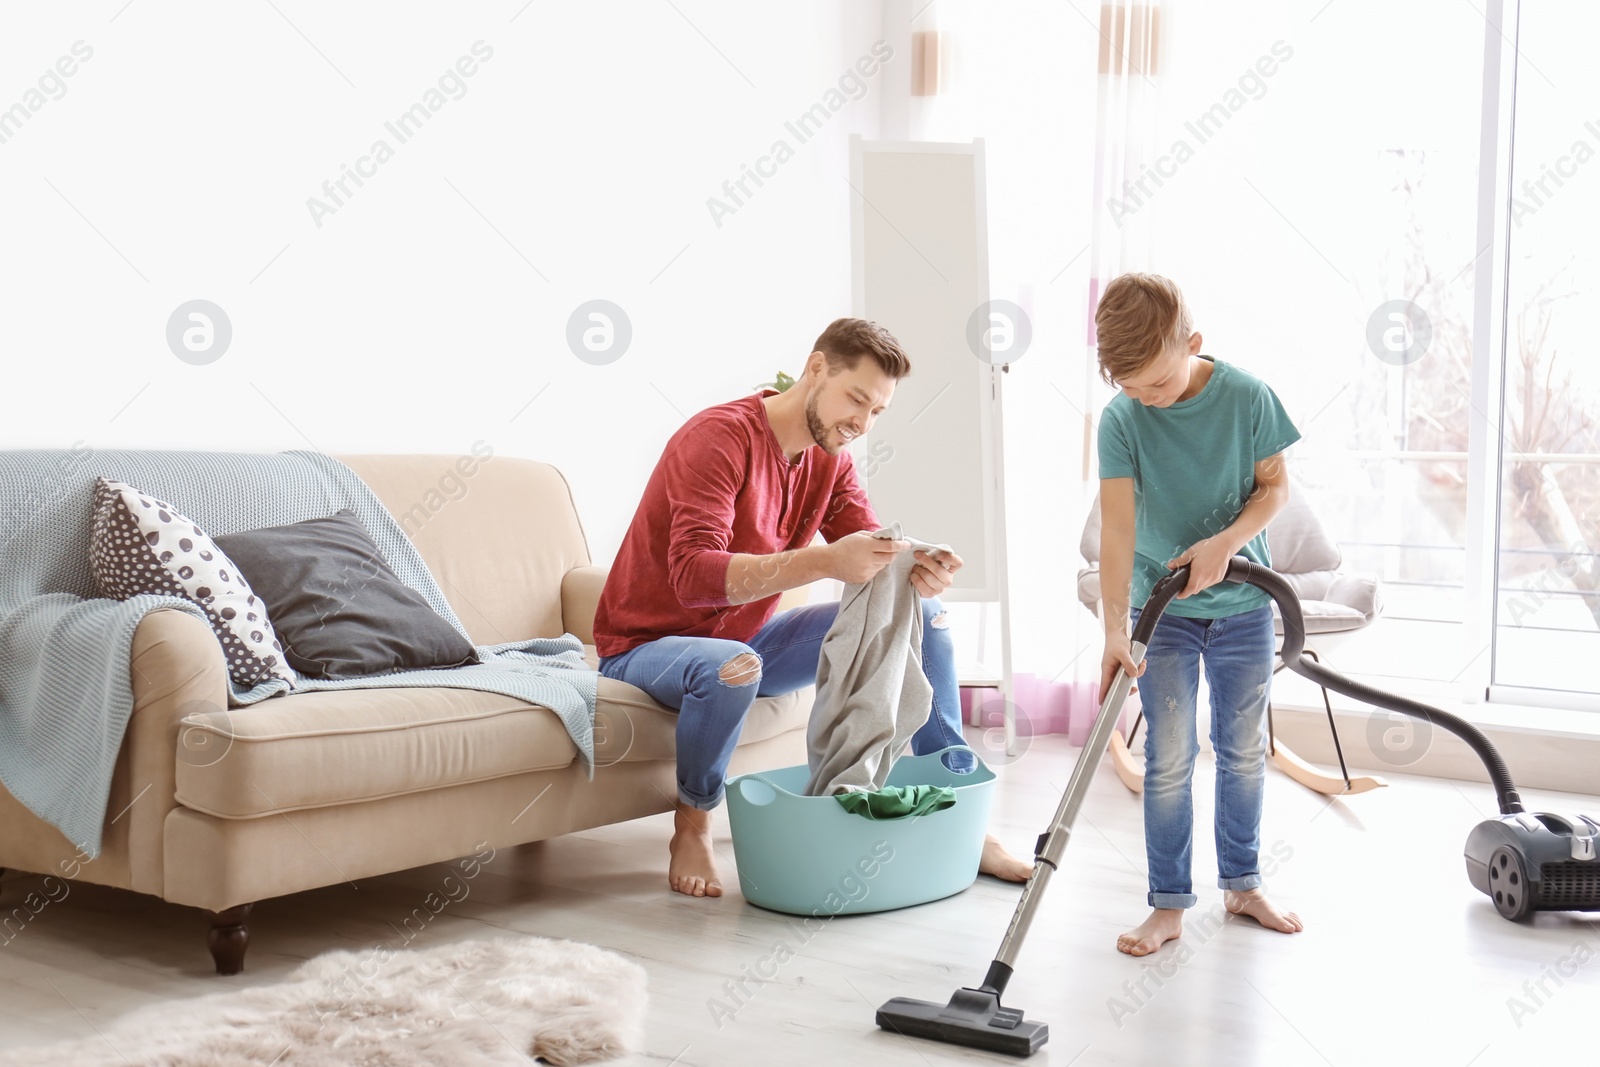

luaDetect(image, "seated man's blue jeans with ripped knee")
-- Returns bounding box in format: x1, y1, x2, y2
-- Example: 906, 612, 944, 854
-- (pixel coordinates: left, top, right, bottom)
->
600, 600, 971, 811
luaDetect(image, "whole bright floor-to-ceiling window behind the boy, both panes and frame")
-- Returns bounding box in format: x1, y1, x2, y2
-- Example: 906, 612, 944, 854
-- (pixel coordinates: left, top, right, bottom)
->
1117, 0, 1600, 705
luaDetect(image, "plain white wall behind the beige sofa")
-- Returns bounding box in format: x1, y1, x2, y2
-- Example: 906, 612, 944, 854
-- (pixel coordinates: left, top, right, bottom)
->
0, 0, 889, 560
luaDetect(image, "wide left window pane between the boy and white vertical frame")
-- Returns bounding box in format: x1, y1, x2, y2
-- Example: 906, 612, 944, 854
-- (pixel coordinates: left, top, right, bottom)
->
1138, 0, 1485, 685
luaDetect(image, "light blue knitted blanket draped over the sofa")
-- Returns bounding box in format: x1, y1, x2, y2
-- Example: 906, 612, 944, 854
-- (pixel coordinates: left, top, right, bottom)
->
0, 448, 597, 856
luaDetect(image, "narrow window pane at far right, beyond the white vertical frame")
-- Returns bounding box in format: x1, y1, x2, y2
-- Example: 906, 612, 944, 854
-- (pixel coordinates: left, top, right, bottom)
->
1493, 3, 1600, 702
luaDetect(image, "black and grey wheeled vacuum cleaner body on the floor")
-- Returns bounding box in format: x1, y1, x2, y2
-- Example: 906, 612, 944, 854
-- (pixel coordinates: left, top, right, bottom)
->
1466, 811, 1600, 920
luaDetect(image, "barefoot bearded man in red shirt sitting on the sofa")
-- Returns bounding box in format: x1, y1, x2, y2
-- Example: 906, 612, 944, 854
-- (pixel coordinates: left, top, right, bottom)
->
594, 318, 1030, 896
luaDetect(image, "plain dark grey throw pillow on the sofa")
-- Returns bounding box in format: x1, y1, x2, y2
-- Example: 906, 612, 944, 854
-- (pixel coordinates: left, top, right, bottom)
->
216, 509, 478, 678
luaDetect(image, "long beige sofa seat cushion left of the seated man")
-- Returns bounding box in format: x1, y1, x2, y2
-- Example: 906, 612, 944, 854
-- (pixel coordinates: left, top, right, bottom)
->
176, 688, 578, 819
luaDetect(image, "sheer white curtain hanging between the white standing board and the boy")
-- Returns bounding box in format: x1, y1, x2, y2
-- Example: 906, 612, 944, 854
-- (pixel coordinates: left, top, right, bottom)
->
885, 0, 1171, 735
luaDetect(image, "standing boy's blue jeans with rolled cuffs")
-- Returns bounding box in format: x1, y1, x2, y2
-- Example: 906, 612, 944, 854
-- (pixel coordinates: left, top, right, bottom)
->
1131, 606, 1275, 909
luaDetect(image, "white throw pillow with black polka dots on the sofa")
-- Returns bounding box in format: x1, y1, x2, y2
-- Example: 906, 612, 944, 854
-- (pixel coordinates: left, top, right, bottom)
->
90, 478, 294, 689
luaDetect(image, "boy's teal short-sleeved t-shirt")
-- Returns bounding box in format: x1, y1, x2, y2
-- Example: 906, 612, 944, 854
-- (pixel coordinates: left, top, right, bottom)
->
1099, 357, 1301, 619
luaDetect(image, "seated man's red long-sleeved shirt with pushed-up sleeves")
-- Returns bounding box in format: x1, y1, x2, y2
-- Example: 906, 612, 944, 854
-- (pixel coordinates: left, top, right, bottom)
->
594, 390, 878, 656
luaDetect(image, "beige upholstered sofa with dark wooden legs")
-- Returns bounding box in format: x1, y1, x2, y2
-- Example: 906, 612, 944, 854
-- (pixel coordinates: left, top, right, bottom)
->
0, 456, 811, 974
